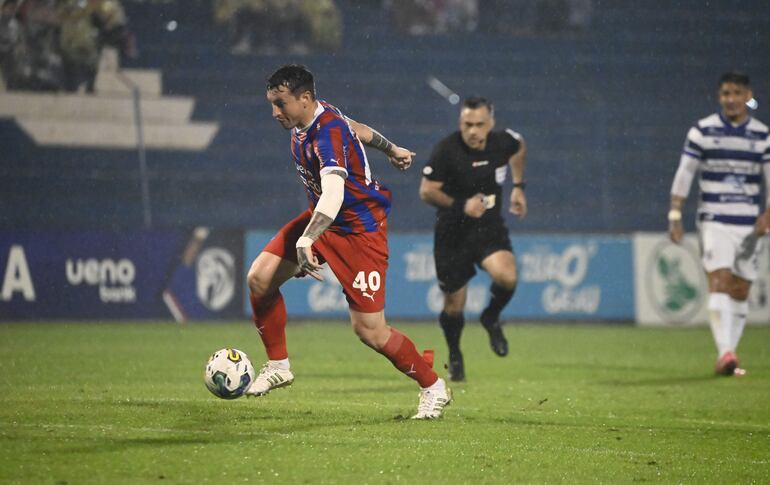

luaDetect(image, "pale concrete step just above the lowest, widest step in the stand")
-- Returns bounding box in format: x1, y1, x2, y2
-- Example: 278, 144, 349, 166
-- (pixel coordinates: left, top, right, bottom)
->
0, 92, 195, 124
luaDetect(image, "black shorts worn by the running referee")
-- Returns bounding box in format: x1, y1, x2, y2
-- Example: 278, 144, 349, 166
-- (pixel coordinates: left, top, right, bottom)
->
433, 220, 513, 293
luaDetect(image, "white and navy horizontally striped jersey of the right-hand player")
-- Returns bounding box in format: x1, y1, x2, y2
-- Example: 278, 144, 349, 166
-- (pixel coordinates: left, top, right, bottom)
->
672, 113, 770, 225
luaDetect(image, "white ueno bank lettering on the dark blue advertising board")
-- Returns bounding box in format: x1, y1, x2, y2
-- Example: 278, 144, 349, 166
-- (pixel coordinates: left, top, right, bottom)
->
65, 258, 136, 303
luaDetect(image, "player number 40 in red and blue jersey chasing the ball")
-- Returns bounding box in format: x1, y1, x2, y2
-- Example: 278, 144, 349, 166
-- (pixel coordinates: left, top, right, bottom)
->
246, 65, 451, 419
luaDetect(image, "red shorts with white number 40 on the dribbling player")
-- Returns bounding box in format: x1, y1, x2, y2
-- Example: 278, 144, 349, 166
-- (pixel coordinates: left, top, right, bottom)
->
263, 209, 388, 313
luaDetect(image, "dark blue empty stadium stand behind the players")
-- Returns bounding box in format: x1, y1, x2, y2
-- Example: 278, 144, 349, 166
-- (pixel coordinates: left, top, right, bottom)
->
0, 0, 770, 232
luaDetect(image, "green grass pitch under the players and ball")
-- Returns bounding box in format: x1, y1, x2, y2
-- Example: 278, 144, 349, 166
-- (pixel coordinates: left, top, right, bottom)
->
0, 321, 770, 484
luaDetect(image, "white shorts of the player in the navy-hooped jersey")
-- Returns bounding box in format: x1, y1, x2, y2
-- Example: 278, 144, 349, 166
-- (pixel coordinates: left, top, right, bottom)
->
698, 221, 762, 281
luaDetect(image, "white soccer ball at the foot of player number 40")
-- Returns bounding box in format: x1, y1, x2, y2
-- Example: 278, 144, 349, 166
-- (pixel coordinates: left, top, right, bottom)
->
203, 349, 255, 399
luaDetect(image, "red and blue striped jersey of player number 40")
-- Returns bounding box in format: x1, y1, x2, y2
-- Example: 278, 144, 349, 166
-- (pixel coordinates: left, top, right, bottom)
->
291, 100, 391, 234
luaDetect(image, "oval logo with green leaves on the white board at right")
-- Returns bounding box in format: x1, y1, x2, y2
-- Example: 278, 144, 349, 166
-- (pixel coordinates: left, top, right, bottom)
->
645, 240, 706, 323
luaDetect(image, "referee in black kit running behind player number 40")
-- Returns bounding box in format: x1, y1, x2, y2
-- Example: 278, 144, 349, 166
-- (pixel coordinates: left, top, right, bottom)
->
420, 96, 527, 381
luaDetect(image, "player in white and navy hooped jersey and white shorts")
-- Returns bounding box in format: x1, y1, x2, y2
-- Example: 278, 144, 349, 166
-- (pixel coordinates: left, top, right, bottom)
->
668, 72, 770, 376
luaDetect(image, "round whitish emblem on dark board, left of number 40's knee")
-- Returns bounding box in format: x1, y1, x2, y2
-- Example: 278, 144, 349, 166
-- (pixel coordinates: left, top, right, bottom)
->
195, 247, 235, 311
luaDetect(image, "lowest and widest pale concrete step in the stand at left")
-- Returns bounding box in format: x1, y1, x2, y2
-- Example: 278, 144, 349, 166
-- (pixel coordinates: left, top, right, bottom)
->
16, 117, 219, 151
